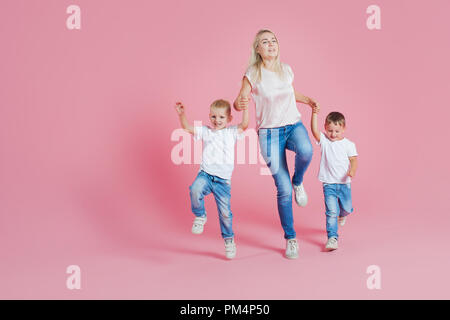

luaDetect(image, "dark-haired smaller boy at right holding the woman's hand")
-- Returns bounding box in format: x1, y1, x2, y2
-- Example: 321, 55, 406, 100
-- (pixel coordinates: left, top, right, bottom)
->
311, 106, 358, 250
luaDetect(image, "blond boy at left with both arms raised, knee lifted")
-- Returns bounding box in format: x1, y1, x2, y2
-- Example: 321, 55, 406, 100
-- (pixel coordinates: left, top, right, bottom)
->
175, 100, 248, 259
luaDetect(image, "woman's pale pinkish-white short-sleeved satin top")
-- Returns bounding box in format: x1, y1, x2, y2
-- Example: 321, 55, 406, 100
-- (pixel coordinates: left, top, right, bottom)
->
245, 63, 301, 129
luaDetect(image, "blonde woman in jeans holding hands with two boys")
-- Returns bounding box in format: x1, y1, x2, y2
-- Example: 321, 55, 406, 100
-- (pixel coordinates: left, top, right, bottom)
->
234, 30, 318, 259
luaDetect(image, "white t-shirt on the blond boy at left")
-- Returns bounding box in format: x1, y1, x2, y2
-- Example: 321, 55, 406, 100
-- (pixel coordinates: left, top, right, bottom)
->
194, 126, 243, 180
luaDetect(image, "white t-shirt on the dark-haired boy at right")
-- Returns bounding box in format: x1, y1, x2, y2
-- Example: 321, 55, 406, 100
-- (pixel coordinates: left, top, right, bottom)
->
318, 132, 358, 184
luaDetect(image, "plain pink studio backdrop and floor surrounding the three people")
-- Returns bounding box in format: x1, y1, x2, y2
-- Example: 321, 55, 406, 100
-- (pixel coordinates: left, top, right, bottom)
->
0, 0, 450, 299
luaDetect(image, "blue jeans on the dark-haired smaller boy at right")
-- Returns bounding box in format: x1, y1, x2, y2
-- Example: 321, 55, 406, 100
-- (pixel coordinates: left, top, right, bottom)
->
323, 183, 353, 239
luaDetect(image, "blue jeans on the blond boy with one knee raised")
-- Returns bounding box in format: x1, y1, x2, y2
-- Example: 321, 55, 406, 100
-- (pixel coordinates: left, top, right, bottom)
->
189, 171, 234, 239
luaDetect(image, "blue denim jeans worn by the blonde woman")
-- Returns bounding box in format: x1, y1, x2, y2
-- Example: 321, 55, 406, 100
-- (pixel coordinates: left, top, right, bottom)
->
258, 121, 313, 239
